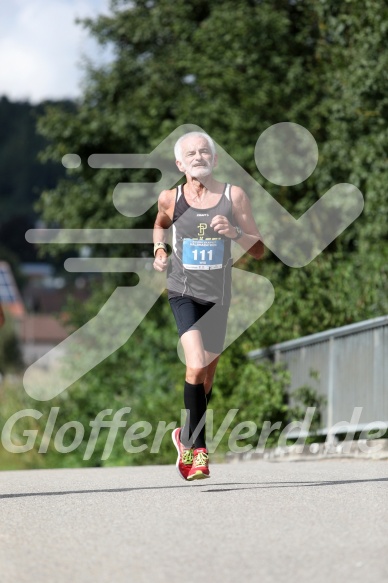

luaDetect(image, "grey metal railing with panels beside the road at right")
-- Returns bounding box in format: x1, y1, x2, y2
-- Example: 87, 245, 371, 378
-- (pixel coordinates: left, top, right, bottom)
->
248, 316, 388, 431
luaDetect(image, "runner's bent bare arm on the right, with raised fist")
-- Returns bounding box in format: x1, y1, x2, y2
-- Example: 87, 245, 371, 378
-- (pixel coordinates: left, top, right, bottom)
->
211, 186, 264, 259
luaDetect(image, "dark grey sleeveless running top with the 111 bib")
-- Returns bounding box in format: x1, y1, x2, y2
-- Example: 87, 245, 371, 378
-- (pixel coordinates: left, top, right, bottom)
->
167, 184, 234, 305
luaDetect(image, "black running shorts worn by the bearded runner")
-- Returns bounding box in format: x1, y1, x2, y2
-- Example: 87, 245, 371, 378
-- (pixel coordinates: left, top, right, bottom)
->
168, 296, 229, 354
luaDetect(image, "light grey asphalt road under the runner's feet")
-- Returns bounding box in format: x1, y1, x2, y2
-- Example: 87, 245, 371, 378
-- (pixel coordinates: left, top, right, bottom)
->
0, 460, 388, 583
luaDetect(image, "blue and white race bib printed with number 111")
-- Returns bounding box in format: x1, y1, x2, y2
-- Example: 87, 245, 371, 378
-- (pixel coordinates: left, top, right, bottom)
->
182, 239, 224, 269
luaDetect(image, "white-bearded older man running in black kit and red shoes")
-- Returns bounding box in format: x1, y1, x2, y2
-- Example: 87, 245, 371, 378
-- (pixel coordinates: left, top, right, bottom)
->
154, 132, 264, 481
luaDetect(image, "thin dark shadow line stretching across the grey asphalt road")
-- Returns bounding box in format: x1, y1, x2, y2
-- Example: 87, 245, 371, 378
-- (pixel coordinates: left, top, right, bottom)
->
0, 478, 388, 500
